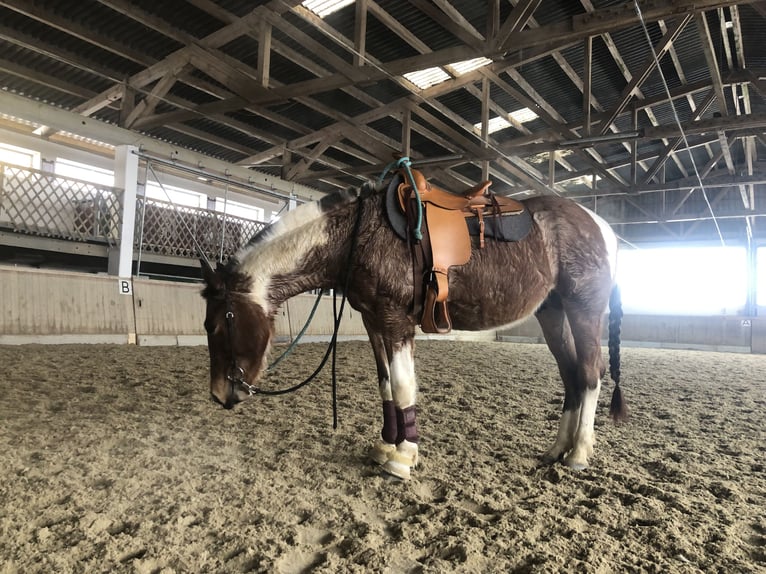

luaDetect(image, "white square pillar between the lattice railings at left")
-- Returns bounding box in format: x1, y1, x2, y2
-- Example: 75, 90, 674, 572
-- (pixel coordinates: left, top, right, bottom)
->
109, 145, 138, 277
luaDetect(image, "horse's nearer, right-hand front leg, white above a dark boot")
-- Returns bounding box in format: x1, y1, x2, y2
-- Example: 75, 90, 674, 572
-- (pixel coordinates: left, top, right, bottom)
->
383, 336, 418, 480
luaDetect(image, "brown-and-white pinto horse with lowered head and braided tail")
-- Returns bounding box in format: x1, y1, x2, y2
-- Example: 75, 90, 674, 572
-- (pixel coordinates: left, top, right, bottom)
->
201, 179, 627, 480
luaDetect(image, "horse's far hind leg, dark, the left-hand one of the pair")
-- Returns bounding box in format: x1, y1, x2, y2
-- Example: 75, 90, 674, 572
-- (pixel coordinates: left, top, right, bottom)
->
535, 292, 582, 464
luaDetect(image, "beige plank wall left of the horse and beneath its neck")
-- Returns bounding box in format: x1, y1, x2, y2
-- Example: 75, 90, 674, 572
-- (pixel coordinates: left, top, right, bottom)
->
0, 266, 365, 345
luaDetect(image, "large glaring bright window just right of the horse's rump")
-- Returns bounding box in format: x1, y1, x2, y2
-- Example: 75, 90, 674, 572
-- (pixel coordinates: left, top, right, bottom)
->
617, 247, 747, 315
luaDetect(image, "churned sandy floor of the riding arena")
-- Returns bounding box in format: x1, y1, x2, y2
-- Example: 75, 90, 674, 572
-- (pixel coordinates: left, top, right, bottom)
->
0, 341, 766, 574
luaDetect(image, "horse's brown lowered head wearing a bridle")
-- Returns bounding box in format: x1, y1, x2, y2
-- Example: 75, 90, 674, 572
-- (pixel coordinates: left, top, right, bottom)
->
201, 260, 274, 409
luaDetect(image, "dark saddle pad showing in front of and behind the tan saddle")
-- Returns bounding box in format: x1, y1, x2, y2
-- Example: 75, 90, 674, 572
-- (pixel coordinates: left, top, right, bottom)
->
386, 174, 532, 241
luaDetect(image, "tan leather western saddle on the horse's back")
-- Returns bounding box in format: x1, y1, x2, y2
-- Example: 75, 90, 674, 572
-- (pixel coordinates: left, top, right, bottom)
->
397, 169, 524, 334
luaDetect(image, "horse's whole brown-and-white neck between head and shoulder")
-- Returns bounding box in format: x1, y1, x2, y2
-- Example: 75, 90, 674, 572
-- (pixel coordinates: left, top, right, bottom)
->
238, 207, 348, 312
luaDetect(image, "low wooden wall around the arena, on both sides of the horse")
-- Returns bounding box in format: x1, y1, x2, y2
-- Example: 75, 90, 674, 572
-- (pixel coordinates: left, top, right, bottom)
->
0, 266, 766, 353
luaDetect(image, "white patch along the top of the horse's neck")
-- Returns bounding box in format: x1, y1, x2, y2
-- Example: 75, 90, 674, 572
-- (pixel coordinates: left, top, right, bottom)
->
237, 203, 328, 313
